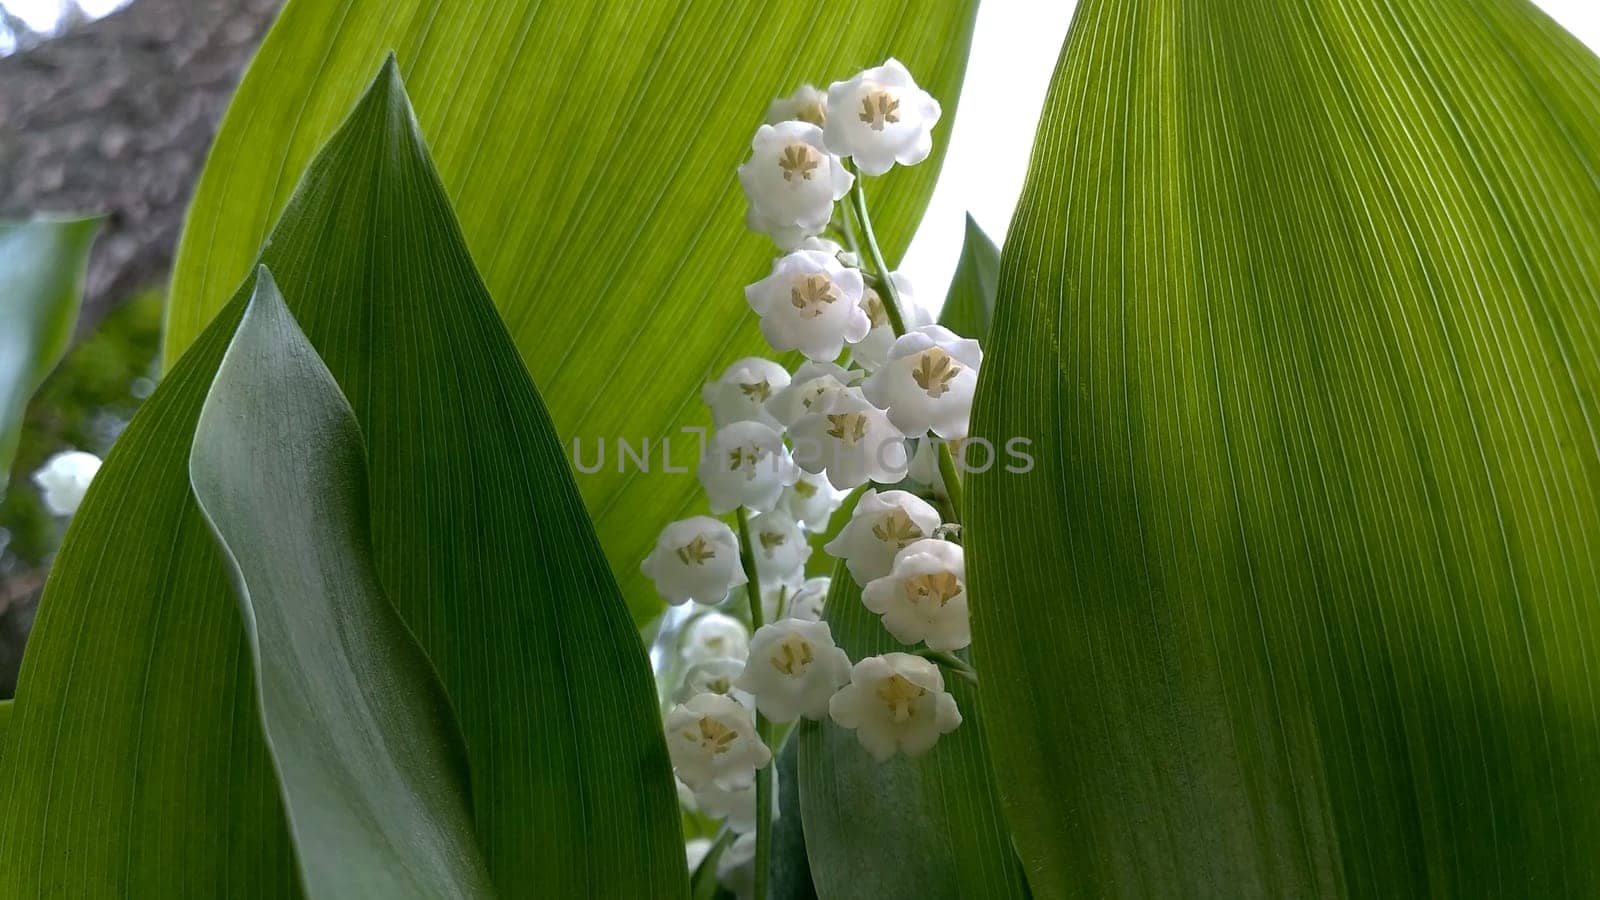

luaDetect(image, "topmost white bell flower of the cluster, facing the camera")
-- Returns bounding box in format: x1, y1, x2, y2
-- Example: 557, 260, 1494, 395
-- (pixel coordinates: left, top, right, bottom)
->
824, 59, 939, 175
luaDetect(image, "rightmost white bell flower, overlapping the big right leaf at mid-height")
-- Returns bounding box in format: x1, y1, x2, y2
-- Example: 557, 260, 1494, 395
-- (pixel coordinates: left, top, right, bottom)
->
861, 325, 984, 440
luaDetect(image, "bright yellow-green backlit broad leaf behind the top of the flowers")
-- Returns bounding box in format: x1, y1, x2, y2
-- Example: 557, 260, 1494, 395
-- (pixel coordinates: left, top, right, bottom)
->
166, 0, 978, 621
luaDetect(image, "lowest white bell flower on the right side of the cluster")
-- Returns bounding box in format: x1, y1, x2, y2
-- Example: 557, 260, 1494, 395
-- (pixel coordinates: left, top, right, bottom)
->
827, 653, 962, 762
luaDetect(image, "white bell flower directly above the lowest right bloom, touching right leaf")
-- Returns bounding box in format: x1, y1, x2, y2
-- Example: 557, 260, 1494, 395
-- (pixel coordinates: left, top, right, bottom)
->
870, 540, 973, 650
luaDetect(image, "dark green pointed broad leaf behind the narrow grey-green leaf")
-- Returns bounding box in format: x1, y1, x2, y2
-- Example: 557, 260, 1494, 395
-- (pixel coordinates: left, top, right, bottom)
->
0, 59, 686, 897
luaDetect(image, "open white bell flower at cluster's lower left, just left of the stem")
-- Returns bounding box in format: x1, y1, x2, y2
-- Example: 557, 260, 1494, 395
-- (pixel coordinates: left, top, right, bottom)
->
666, 693, 773, 791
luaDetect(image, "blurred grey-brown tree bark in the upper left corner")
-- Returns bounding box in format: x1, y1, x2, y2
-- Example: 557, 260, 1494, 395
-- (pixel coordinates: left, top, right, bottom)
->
0, 0, 282, 336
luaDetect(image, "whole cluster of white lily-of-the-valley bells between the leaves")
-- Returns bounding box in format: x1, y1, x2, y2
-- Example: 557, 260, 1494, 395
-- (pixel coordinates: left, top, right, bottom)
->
642, 59, 982, 882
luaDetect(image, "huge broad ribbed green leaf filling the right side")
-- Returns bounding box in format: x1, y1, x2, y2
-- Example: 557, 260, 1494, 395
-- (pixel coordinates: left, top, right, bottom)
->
966, 0, 1600, 897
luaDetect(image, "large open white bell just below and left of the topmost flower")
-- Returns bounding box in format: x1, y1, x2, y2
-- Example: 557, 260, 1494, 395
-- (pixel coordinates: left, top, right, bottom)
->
739, 122, 856, 250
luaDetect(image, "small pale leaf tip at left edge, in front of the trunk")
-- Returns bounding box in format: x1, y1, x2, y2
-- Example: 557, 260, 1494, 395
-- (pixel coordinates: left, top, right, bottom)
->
0, 218, 101, 483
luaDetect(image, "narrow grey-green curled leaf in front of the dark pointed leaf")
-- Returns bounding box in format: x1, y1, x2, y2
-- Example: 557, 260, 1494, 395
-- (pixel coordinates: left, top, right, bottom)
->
189, 267, 491, 897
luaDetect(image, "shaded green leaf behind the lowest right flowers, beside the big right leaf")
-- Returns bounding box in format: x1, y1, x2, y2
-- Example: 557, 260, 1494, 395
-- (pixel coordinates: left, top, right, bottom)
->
795, 564, 1027, 900
